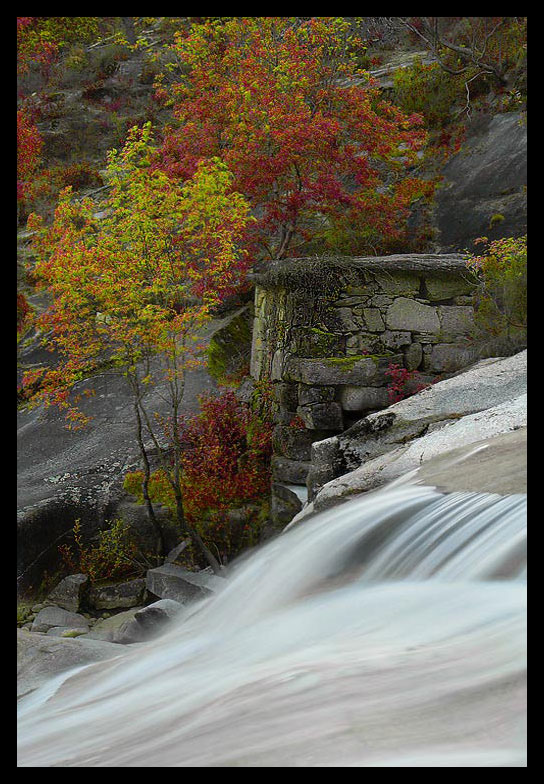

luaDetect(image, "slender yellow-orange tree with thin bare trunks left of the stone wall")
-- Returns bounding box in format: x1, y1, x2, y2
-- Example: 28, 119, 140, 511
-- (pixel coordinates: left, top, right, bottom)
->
21, 123, 249, 570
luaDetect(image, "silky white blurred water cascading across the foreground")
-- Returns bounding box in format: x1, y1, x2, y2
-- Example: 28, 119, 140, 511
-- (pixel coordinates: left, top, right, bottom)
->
19, 485, 526, 767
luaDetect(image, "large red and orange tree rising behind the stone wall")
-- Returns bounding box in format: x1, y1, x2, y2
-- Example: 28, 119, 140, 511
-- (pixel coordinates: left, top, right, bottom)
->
158, 17, 429, 259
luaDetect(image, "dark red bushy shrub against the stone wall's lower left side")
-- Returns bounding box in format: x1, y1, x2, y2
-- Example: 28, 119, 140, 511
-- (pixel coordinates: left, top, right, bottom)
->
124, 384, 272, 560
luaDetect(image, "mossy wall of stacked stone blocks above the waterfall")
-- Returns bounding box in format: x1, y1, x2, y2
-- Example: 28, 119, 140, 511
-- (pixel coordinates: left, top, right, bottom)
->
251, 254, 475, 524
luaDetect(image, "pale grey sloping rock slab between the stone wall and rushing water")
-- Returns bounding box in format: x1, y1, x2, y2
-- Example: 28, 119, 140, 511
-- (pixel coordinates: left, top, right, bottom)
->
294, 351, 527, 521
